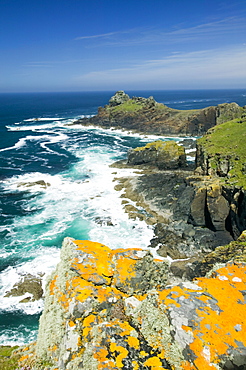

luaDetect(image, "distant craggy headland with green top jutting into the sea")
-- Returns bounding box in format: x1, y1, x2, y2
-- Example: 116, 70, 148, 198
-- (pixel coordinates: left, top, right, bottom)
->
75, 91, 244, 136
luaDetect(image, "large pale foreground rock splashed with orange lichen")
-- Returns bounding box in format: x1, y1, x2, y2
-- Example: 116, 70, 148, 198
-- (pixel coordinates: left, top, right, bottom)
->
20, 238, 246, 370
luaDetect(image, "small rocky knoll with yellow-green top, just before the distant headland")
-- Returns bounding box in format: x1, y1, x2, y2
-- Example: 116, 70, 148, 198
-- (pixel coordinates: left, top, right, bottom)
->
127, 140, 186, 170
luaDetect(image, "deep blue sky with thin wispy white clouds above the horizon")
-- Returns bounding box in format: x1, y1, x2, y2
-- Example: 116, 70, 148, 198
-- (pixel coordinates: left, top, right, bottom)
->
0, 0, 246, 92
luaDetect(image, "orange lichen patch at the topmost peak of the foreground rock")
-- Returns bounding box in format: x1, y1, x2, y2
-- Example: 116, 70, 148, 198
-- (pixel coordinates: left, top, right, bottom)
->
72, 240, 113, 284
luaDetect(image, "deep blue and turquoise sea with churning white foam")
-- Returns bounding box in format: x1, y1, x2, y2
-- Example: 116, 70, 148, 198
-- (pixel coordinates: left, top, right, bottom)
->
0, 89, 246, 345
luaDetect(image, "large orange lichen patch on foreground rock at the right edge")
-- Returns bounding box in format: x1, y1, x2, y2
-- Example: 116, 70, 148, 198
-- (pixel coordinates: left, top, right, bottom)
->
186, 265, 246, 370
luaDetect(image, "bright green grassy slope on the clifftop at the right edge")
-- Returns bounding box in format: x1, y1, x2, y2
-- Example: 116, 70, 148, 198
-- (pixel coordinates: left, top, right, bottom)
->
198, 118, 246, 189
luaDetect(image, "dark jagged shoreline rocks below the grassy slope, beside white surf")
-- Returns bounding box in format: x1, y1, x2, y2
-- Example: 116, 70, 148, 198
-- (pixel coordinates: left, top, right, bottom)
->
112, 163, 239, 258
